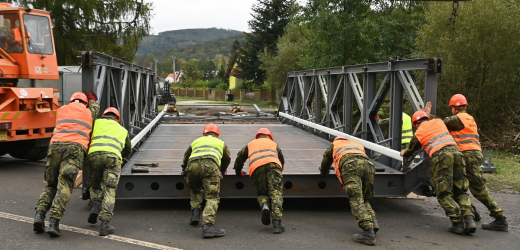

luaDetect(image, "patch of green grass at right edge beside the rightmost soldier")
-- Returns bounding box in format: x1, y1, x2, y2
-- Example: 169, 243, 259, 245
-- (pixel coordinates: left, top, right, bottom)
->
484, 151, 520, 193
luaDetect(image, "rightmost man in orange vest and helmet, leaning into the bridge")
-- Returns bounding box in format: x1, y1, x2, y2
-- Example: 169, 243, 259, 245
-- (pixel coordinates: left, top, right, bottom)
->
425, 94, 509, 232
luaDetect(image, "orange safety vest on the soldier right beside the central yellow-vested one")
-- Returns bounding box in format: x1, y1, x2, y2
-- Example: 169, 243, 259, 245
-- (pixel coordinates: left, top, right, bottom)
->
247, 138, 282, 176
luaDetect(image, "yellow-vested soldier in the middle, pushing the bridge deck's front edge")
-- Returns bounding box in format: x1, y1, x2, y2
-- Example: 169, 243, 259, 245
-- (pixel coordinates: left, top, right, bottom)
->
181, 124, 231, 238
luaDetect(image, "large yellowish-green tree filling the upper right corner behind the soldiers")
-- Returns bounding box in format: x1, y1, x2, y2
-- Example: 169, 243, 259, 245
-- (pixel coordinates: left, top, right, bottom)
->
417, 0, 520, 141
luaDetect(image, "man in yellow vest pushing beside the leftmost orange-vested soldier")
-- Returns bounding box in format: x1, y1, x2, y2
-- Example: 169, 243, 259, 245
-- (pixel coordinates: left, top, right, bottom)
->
87, 107, 132, 236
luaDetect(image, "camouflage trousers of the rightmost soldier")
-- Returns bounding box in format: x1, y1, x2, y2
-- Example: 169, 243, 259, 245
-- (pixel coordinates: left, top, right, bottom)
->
462, 150, 505, 218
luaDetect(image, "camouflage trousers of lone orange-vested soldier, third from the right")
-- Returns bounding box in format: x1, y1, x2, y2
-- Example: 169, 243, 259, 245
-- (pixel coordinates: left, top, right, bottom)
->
340, 154, 376, 229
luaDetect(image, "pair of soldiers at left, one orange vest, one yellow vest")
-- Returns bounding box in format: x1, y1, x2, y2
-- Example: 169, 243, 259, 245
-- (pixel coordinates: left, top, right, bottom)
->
33, 91, 132, 237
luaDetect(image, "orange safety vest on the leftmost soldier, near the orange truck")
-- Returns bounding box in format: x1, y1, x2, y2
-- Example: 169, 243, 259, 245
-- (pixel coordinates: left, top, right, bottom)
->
51, 102, 92, 150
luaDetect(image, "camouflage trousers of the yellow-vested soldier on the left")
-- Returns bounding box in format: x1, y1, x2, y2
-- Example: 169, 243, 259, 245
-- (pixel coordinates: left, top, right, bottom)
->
86, 152, 121, 221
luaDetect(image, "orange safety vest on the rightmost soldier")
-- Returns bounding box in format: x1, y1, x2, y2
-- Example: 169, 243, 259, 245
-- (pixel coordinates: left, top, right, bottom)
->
450, 112, 482, 152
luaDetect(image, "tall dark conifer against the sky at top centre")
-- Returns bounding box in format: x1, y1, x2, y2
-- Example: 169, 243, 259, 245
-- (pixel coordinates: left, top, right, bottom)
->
238, 0, 294, 86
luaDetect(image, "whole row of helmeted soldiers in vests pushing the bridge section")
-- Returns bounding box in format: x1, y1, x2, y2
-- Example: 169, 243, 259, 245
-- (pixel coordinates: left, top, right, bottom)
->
30, 92, 508, 245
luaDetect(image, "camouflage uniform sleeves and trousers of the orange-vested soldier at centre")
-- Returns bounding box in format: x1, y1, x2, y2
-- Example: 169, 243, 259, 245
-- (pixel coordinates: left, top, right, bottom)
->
233, 146, 285, 220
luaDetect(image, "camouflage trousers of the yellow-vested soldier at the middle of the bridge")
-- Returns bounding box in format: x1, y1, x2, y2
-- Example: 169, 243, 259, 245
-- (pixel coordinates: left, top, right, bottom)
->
186, 159, 222, 225
